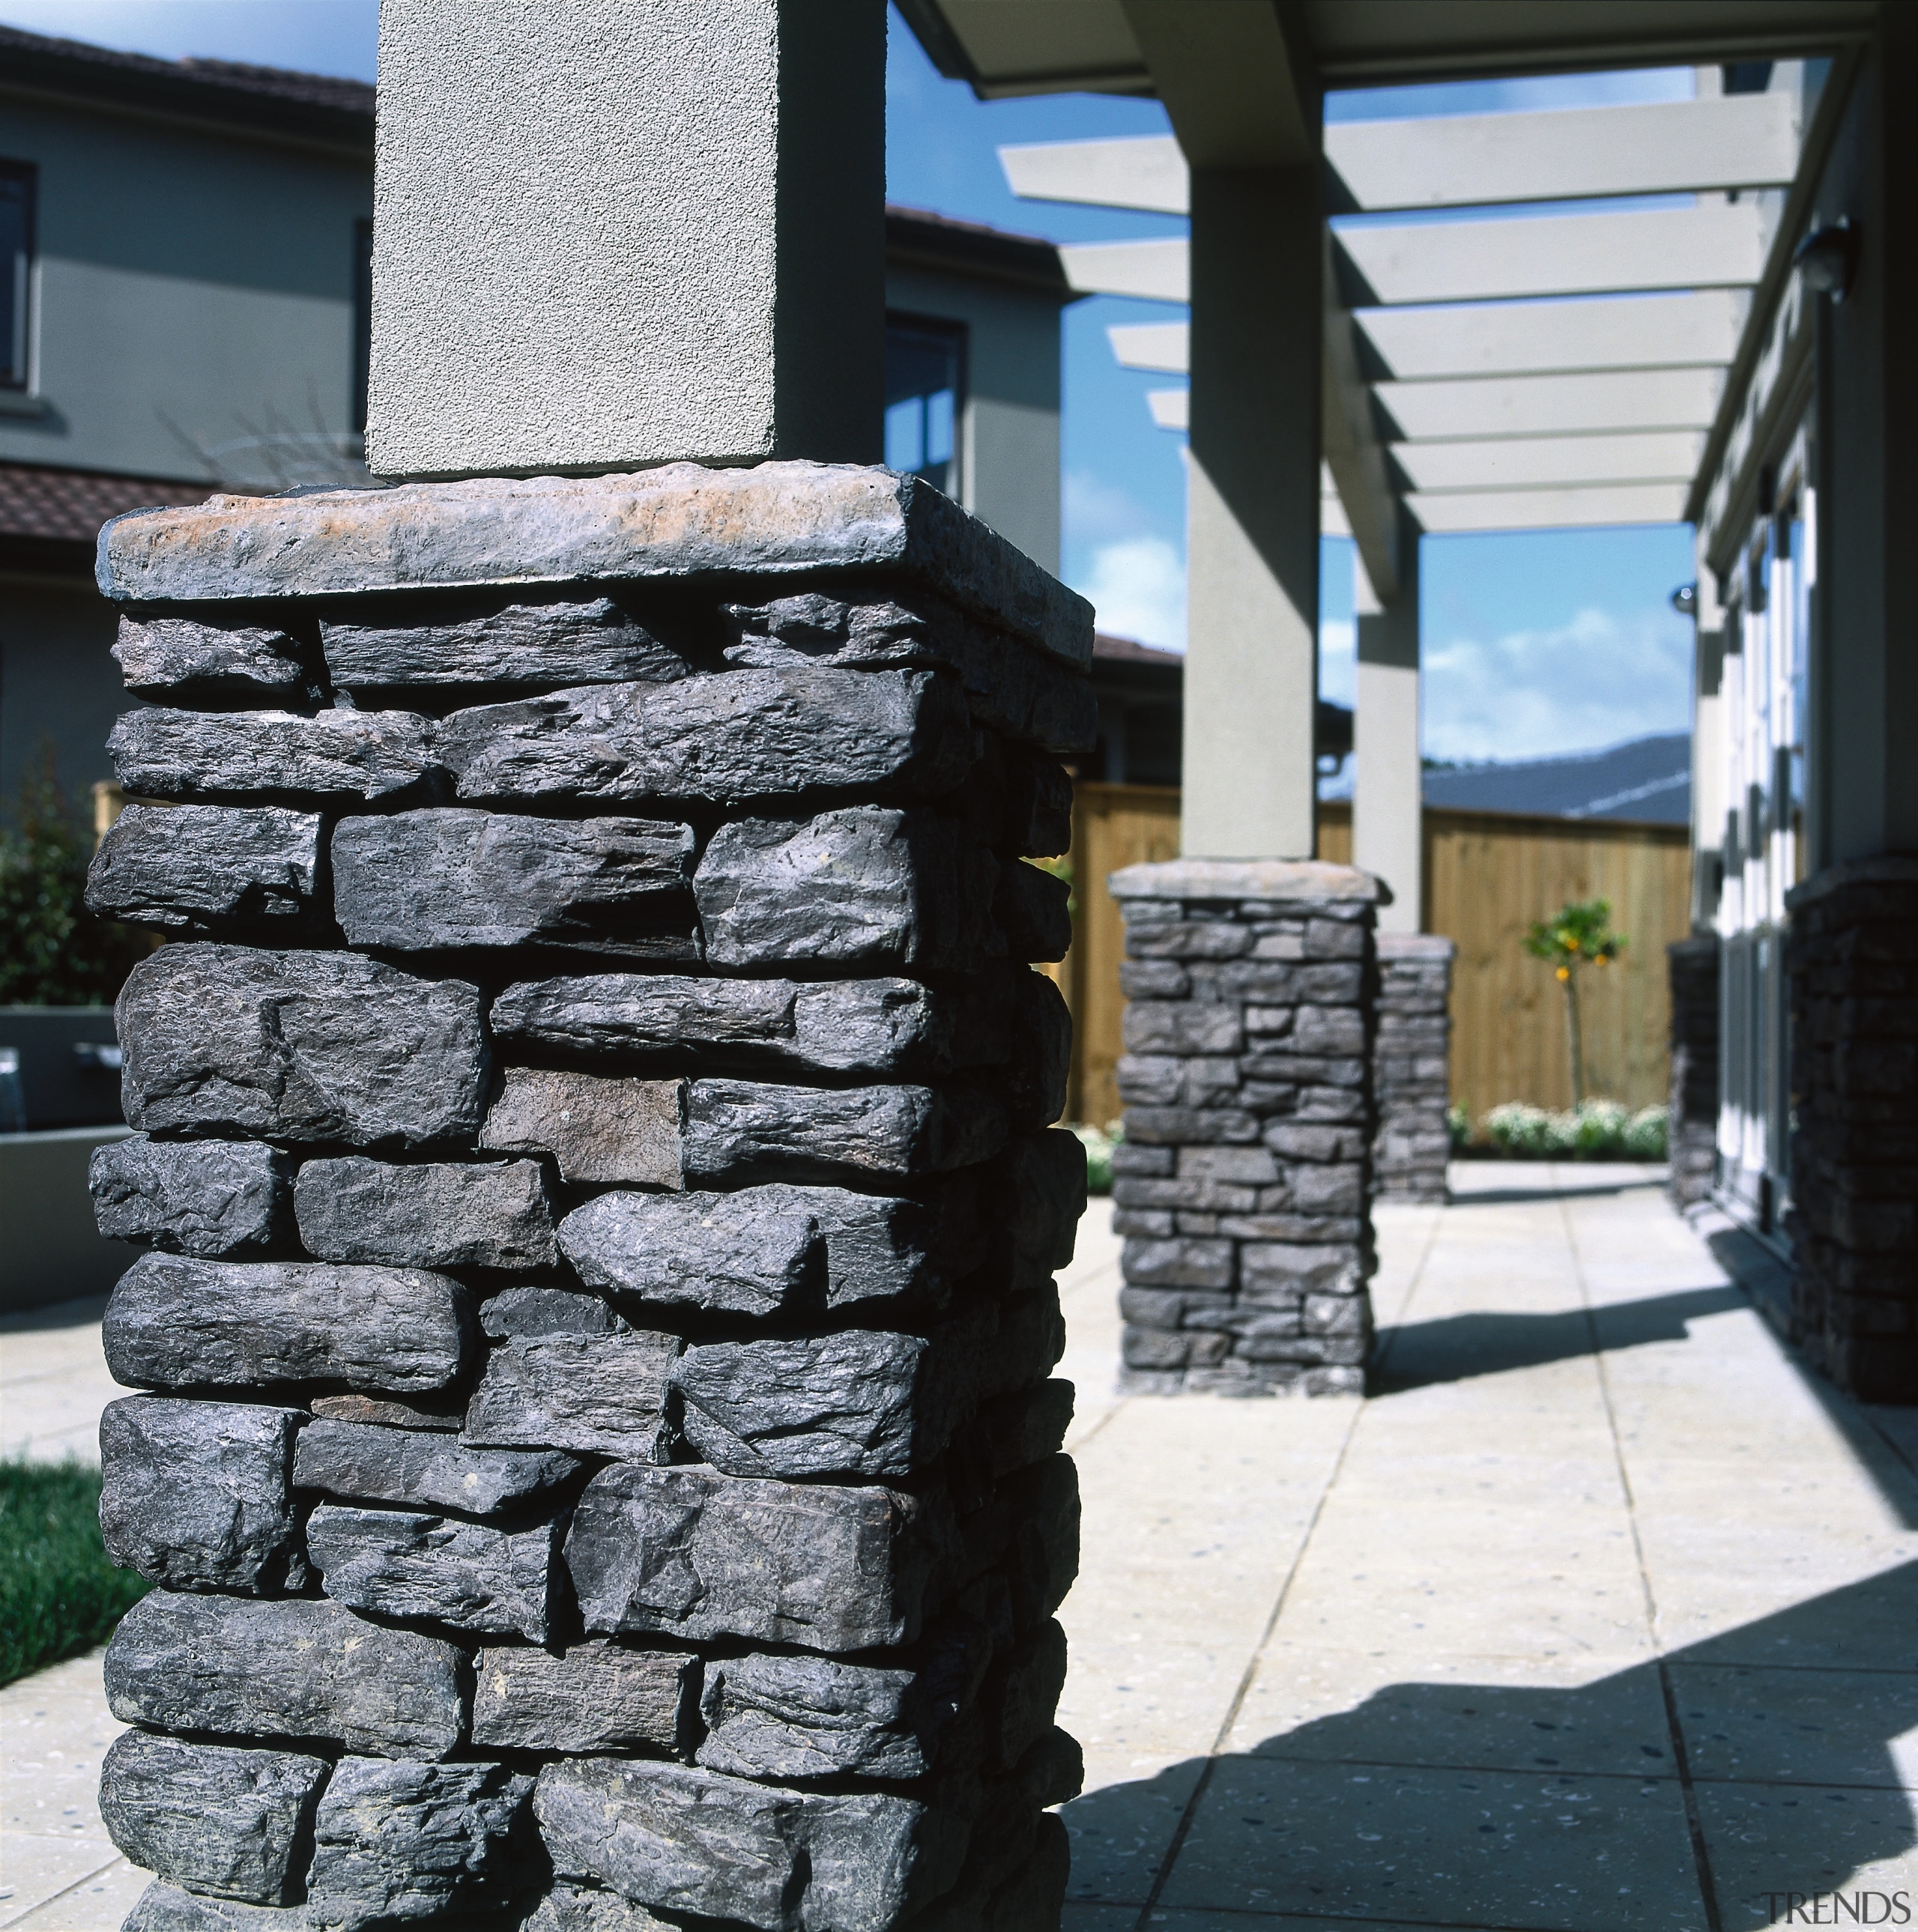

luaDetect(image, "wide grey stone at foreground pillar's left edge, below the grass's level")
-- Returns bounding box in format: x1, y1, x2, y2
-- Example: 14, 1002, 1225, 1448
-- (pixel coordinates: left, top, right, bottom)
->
106, 1590, 465, 1758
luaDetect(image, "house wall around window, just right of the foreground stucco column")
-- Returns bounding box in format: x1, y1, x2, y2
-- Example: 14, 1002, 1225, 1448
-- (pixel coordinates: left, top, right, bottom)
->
886, 264, 1060, 572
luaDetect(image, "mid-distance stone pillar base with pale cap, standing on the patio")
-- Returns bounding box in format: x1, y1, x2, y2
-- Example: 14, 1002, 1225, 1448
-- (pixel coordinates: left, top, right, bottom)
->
1110, 860, 1379, 1395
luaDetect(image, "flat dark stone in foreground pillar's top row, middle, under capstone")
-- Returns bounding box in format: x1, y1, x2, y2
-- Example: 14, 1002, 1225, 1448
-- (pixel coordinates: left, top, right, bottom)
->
321, 597, 688, 695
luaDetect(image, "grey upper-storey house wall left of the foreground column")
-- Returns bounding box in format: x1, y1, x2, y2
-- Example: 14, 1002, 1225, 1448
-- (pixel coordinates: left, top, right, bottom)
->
0, 97, 373, 488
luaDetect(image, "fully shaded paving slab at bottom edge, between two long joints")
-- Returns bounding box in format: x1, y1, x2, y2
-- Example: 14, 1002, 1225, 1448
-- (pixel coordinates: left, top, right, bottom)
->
1151, 1758, 1704, 1932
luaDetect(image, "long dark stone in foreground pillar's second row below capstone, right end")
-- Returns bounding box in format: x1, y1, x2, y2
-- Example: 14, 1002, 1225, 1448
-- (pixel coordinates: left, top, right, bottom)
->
432, 667, 973, 804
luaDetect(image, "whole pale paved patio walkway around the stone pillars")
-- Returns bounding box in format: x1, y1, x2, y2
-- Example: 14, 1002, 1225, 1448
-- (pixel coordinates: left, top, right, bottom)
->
0, 1165, 1918, 1932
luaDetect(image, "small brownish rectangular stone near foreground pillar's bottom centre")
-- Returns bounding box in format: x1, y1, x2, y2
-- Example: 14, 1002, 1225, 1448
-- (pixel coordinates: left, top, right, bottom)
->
474, 1636, 699, 1756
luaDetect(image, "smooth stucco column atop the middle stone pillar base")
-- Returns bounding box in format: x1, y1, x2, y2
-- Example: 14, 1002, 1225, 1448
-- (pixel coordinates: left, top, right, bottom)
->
1180, 168, 1323, 858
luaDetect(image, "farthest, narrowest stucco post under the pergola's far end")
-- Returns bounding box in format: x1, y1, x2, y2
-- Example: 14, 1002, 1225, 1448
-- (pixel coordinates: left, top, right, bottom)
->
1352, 506, 1426, 933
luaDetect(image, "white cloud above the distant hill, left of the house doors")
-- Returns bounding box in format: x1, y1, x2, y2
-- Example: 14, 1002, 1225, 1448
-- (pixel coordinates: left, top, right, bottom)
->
1421, 608, 1692, 763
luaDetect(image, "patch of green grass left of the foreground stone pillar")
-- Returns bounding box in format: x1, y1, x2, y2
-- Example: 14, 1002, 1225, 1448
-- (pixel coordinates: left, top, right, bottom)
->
0, 1462, 147, 1685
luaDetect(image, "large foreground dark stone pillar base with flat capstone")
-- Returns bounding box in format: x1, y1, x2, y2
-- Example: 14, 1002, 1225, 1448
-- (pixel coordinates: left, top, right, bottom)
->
91, 464, 1089, 1932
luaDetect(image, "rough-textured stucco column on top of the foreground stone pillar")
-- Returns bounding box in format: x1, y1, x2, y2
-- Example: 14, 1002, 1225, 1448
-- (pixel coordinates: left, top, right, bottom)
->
367, 0, 885, 475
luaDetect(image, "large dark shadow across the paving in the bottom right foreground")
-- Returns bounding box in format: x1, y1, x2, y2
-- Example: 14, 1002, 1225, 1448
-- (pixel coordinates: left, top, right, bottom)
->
1065, 1563, 1918, 1932
